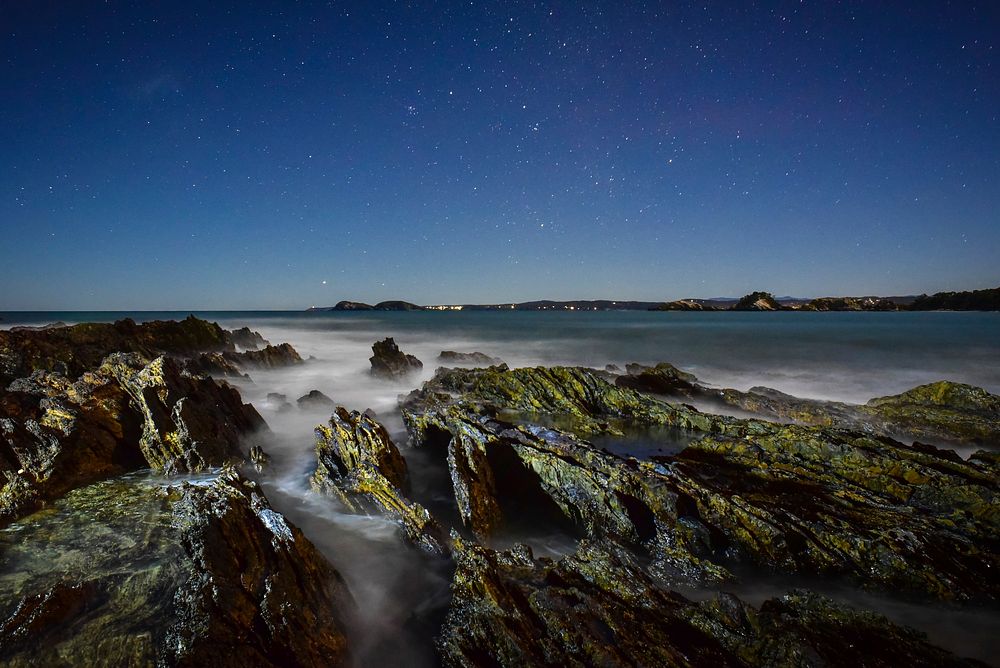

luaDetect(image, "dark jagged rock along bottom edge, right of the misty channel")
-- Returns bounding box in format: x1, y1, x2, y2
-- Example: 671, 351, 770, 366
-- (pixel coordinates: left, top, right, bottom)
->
437, 537, 974, 668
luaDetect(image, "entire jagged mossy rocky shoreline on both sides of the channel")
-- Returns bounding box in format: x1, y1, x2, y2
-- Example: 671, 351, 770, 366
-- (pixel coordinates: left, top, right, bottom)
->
0, 318, 1000, 667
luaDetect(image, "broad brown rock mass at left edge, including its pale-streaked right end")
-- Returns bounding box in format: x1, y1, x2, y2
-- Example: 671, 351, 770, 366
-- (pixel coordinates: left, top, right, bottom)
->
0, 353, 265, 524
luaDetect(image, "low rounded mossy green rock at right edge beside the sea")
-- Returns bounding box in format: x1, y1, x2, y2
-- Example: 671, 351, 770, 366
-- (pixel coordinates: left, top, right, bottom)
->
862, 380, 1000, 448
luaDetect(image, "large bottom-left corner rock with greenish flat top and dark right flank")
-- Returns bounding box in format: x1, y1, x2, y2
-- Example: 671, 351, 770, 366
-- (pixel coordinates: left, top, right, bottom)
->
0, 471, 353, 666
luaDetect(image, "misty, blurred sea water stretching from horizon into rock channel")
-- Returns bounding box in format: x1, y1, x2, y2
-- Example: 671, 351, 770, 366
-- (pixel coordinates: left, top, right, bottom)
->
0, 312, 1000, 666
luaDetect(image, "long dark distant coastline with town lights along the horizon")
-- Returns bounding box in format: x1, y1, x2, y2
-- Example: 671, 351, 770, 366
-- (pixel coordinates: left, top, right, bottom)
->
306, 287, 1000, 312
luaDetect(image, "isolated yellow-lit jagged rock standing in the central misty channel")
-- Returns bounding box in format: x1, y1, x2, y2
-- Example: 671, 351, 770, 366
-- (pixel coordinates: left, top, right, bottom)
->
312, 406, 449, 554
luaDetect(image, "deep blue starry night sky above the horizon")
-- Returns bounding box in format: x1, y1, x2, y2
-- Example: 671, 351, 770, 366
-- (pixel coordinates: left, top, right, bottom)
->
0, 0, 1000, 310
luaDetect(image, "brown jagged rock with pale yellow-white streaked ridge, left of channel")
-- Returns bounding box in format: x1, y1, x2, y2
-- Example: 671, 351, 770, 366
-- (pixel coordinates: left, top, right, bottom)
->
100, 353, 266, 473
